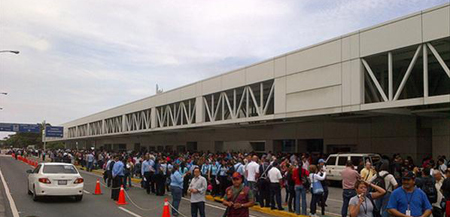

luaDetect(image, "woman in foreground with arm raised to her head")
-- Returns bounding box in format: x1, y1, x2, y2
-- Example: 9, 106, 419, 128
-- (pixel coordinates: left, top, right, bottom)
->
349, 180, 386, 217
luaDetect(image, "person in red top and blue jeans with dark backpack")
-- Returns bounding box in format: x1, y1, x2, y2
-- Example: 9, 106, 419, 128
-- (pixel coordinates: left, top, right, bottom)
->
292, 162, 311, 215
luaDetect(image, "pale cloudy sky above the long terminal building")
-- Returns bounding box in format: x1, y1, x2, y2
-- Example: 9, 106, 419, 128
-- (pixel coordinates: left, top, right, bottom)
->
0, 0, 450, 138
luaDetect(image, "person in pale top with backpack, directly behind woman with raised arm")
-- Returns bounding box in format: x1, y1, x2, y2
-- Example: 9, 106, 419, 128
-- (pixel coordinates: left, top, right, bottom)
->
369, 161, 398, 217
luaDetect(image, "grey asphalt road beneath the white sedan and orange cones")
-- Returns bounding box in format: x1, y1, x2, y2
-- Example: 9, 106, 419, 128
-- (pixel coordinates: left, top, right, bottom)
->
0, 156, 280, 217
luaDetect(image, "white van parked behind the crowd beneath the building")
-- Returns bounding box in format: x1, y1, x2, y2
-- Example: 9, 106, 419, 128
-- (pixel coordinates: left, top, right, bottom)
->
325, 153, 381, 181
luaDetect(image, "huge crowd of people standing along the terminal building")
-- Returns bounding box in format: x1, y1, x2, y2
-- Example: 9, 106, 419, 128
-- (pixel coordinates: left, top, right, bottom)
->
9, 150, 450, 217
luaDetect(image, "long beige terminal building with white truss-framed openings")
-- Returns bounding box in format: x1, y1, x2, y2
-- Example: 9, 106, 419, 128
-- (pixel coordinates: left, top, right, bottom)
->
53, 4, 450, 159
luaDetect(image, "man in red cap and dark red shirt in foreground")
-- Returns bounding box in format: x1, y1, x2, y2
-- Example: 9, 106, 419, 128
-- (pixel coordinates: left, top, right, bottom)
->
223, 172, 254, 217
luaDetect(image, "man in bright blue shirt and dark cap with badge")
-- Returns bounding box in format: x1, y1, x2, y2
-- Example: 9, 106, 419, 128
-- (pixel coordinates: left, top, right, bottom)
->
387, 172, 433, 217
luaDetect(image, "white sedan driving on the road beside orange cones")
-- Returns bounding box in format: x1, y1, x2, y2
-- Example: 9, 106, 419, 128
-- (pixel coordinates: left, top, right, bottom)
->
27, 163, 84, 201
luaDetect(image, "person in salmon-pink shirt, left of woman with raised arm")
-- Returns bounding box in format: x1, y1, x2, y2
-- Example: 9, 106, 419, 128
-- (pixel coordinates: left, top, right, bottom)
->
341, 160, 361, 217
